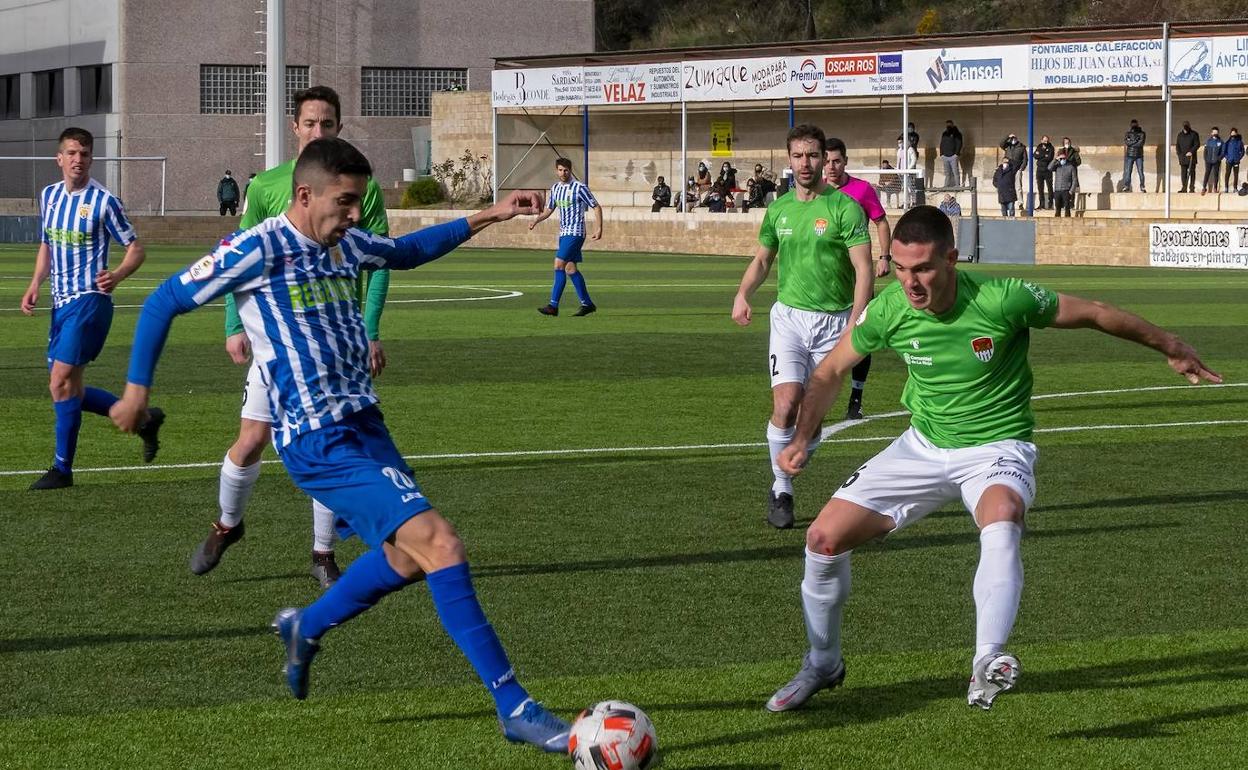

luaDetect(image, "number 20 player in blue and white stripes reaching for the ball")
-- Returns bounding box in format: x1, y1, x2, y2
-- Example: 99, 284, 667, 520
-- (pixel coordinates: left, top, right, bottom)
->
112, 139, 568, 753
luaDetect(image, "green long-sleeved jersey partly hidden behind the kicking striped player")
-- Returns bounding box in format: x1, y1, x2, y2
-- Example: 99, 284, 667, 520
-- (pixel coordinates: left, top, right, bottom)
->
226, 160, 389, 341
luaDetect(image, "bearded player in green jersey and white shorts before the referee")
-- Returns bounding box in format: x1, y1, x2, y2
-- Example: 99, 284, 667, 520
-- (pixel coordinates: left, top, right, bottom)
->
733, 125, 874, 529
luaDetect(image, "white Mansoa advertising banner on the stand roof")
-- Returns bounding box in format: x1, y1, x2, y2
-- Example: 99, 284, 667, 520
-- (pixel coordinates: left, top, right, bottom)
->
901, 45, 1031, 94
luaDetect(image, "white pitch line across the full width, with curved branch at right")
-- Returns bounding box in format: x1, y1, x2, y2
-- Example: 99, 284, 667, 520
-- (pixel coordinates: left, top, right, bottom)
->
0, 382, 1248, 477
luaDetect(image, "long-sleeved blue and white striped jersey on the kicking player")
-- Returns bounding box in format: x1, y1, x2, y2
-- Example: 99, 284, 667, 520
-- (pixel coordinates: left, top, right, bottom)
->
129, 215, 470, 449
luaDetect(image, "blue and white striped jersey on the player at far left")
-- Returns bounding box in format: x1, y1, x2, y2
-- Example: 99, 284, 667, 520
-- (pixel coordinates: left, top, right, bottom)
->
39, 180, 139, 307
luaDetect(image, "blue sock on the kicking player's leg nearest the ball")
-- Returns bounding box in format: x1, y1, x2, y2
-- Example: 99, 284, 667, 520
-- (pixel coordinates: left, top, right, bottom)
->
426, 563, 529, 716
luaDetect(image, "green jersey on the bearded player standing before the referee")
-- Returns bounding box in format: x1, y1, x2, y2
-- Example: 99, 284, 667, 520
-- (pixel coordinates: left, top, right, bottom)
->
759, 187, 871, 313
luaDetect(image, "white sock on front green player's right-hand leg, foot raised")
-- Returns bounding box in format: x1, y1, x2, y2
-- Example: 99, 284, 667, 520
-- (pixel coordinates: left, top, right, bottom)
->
973, 522, 1022, 663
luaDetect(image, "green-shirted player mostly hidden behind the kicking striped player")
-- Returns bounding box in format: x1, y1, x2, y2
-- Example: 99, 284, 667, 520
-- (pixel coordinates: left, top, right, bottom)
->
183, 86, 389, 588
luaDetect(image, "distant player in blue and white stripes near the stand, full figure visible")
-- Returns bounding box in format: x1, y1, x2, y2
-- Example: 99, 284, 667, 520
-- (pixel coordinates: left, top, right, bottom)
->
529, 157, 603, 316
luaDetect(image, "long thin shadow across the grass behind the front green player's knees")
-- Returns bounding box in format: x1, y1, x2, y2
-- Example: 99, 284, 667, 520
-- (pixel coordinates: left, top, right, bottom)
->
473, 522, 1181, 578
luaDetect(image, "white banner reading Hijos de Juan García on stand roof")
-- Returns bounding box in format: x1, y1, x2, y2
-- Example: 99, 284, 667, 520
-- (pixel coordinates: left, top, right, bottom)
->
1031, 39, 1164, 91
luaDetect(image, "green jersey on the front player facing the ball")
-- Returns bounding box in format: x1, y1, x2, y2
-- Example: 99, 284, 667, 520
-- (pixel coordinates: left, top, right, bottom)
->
852, 271, 1057, 449
